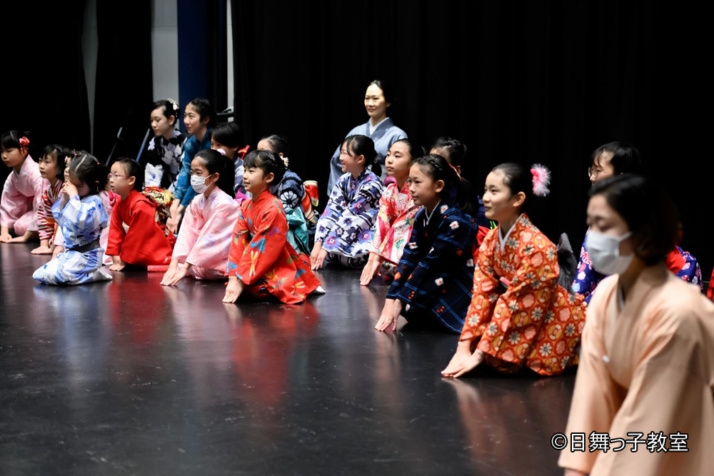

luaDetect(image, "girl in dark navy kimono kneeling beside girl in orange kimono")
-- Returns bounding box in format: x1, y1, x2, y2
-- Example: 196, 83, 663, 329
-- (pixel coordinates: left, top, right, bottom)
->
375, 155, 478, 332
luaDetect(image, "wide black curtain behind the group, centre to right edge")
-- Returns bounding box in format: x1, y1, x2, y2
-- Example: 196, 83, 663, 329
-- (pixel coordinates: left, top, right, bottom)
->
233, 0, 714, 274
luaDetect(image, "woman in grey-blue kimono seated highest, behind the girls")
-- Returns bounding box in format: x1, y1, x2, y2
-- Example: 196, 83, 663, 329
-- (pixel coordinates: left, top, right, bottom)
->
327, 79, 407, 195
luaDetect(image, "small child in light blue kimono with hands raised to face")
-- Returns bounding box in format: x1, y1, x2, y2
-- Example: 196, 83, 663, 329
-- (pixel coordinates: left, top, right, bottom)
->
32, 152, 112, 285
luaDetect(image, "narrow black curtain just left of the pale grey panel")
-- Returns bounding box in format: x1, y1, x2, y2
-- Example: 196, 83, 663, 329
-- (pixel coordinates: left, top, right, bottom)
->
94, 0, 153, 161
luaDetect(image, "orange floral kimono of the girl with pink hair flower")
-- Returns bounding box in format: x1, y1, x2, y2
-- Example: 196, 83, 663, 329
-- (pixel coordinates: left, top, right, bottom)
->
460, 214, 585, 375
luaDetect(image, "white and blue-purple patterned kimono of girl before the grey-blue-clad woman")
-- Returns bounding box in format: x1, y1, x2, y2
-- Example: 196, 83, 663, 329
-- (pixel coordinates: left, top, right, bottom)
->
315, 169, 384, 264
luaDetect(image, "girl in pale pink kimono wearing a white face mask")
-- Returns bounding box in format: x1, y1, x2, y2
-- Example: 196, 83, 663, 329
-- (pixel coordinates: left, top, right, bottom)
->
161, 150, 240, 286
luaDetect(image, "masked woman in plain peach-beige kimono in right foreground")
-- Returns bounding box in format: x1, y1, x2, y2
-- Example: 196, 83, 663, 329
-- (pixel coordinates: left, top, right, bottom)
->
559, 175, 714, 476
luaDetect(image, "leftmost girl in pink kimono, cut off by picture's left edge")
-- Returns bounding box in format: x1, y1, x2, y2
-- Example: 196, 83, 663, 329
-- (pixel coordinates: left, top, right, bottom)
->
0, 131, 49, 243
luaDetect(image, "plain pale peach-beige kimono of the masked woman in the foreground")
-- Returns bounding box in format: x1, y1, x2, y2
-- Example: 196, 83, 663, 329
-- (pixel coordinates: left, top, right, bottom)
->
558, 264, 714, 476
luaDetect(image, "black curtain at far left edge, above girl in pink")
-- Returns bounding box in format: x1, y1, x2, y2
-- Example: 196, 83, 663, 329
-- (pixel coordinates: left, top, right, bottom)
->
0, 1, 90, 183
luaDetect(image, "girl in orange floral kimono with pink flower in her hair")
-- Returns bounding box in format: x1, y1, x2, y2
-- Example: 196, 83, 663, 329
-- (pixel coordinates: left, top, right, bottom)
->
442, 164, 585, 377
